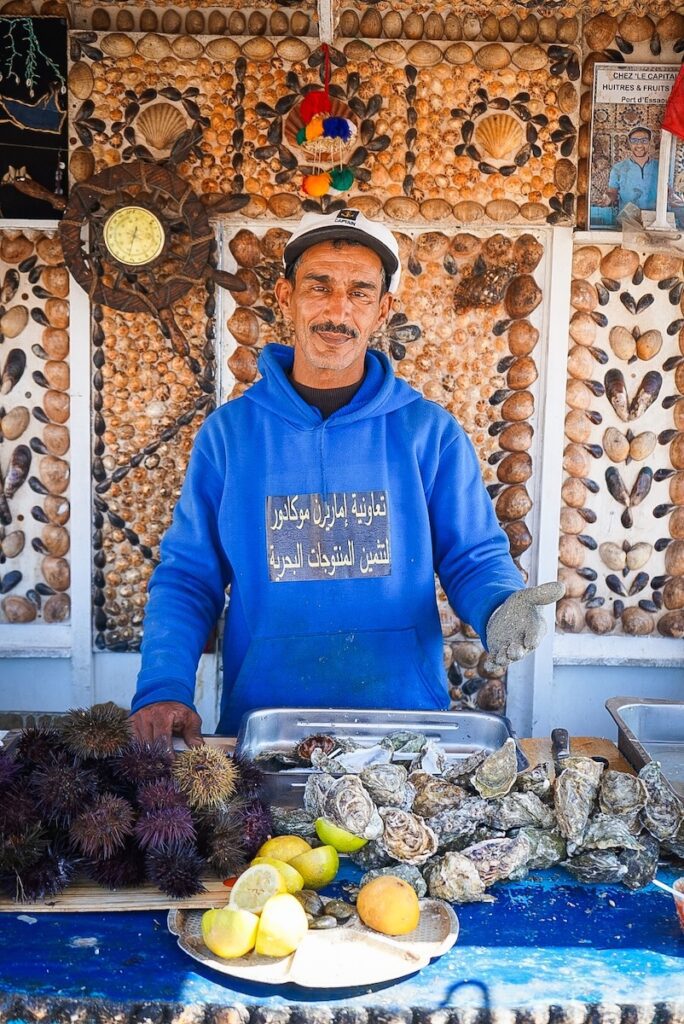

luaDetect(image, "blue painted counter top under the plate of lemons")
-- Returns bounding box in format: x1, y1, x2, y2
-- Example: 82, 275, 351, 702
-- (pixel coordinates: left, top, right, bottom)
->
0, 867, 684, 1024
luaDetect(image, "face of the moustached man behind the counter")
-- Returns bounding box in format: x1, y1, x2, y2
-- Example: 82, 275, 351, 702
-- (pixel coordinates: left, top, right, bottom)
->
275, 242, 392, 387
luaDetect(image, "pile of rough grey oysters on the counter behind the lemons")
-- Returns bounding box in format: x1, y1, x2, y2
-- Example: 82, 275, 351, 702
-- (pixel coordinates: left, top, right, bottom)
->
273, 733, 684, 903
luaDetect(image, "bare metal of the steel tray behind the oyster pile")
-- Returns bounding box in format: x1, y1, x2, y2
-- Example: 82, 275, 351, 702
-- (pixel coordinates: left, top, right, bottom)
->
236, 708, 529, 808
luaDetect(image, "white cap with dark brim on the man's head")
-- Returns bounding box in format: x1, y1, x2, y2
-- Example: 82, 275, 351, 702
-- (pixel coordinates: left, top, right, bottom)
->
283, 209, 401, 293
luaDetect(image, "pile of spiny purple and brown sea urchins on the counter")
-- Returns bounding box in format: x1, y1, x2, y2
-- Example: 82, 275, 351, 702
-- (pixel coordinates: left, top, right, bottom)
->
0, 702, 272, 901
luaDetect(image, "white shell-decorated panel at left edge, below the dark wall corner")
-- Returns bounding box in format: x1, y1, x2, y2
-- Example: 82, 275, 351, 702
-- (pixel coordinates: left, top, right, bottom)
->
0, 228, 71, 623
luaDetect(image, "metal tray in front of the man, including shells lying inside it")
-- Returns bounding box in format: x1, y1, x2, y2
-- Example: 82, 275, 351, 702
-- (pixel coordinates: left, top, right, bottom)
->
236, 708, 528, 808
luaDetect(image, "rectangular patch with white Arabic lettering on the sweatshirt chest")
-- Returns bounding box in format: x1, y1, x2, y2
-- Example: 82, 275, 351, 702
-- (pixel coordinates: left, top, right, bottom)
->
266, 490, 392, 583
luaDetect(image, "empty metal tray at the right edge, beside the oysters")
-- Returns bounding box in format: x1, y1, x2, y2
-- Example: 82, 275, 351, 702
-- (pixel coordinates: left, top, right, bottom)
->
605, 697, 684, 800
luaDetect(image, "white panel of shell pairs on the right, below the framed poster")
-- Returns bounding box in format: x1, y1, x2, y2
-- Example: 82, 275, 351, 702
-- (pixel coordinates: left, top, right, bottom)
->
557, 246, 684, 638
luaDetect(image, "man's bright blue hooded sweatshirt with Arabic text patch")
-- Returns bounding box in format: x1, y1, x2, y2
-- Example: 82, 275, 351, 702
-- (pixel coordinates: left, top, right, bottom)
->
132, 345, 523, 734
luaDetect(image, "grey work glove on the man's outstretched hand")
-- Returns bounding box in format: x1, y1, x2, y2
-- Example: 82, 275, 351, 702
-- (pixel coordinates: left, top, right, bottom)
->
484, 583, 565, 673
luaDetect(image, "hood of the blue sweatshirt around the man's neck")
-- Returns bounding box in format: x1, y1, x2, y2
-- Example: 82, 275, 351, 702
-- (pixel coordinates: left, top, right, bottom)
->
244, 344, 420, 430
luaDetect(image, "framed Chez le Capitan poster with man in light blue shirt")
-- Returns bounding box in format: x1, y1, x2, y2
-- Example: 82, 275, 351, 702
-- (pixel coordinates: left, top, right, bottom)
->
588, 63, 682, 228
